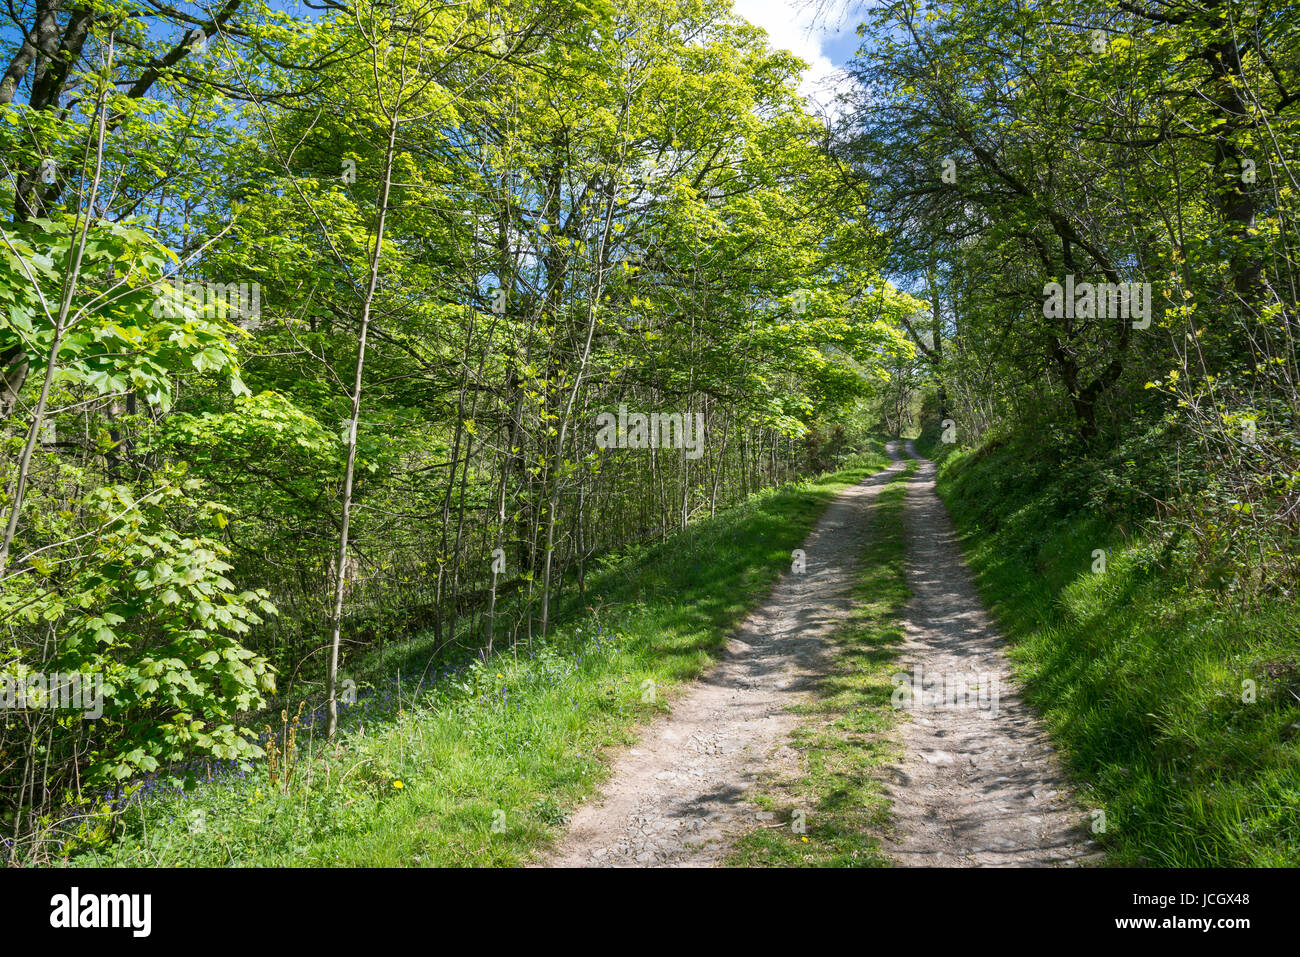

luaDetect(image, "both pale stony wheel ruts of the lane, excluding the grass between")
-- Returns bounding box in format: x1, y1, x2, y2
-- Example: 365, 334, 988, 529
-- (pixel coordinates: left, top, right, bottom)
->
538, 442, 1092, 867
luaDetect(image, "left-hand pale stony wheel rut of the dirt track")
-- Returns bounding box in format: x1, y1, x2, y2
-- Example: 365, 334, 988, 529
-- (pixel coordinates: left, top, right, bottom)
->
541, 443, 901, 867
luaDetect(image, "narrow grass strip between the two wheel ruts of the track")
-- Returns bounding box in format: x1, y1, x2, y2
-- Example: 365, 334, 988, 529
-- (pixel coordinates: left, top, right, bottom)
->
731, 462, 917, 867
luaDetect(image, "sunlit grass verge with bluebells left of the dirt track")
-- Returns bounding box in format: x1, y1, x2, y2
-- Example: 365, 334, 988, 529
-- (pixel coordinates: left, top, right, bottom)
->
73, 450, 887, 867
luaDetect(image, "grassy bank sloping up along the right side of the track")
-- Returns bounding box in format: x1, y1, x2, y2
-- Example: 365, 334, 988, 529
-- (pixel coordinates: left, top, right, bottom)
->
939, 441, 1300, 866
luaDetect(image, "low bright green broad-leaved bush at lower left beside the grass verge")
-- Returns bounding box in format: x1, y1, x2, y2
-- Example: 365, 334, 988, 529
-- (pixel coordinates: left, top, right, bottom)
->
0, 475, 274, 787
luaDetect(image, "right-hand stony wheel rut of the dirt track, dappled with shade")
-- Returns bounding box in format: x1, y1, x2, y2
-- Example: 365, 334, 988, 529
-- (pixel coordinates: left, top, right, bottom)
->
885, 442, 1095, 867
